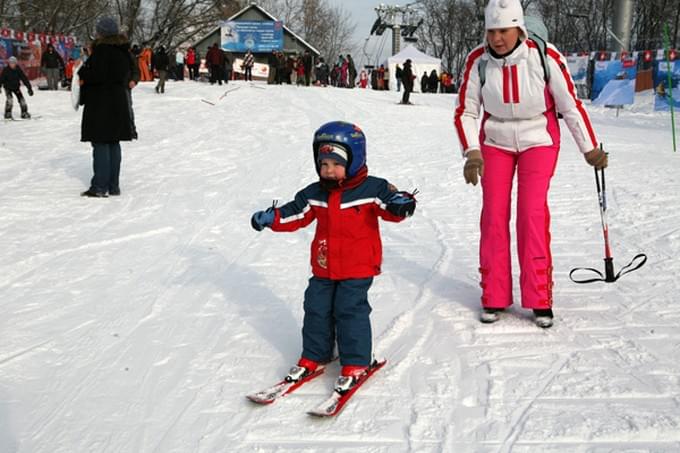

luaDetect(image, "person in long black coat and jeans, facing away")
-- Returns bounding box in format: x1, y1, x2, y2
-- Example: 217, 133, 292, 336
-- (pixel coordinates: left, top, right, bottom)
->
78, 17, 134, 197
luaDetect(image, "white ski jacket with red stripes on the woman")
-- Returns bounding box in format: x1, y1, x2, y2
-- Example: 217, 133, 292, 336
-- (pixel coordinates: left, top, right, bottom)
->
454, 39, 598, 155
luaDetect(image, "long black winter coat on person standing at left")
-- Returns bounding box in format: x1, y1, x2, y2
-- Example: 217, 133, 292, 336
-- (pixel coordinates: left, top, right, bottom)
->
78, 35, 133, 143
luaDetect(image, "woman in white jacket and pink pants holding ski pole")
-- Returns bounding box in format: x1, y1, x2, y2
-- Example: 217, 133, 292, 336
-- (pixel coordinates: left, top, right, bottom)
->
454, 0, 607, 328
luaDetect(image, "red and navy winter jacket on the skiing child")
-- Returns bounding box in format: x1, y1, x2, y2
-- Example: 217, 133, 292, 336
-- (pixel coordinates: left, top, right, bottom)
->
271, 167, 404, 280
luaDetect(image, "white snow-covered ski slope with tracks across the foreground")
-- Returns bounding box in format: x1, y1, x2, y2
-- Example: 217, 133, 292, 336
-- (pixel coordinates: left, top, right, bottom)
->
0, 82, 680, 453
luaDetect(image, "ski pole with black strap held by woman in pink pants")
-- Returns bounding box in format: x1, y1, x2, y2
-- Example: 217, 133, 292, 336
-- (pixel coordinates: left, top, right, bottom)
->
569, 152, 647, 283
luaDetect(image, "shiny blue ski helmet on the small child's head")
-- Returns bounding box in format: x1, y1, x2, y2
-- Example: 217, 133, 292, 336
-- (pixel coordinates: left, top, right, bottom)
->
312, 121, 366, 178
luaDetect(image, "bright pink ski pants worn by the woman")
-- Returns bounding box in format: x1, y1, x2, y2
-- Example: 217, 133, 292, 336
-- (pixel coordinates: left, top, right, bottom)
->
479, 142, 559, 309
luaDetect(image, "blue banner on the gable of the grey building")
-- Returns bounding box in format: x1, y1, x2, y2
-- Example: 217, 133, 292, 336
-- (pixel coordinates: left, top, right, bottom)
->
220, 20, 283, 52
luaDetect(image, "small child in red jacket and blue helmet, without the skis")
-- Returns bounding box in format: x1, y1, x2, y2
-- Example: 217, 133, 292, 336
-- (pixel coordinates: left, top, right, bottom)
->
251, 121, 416, 393
